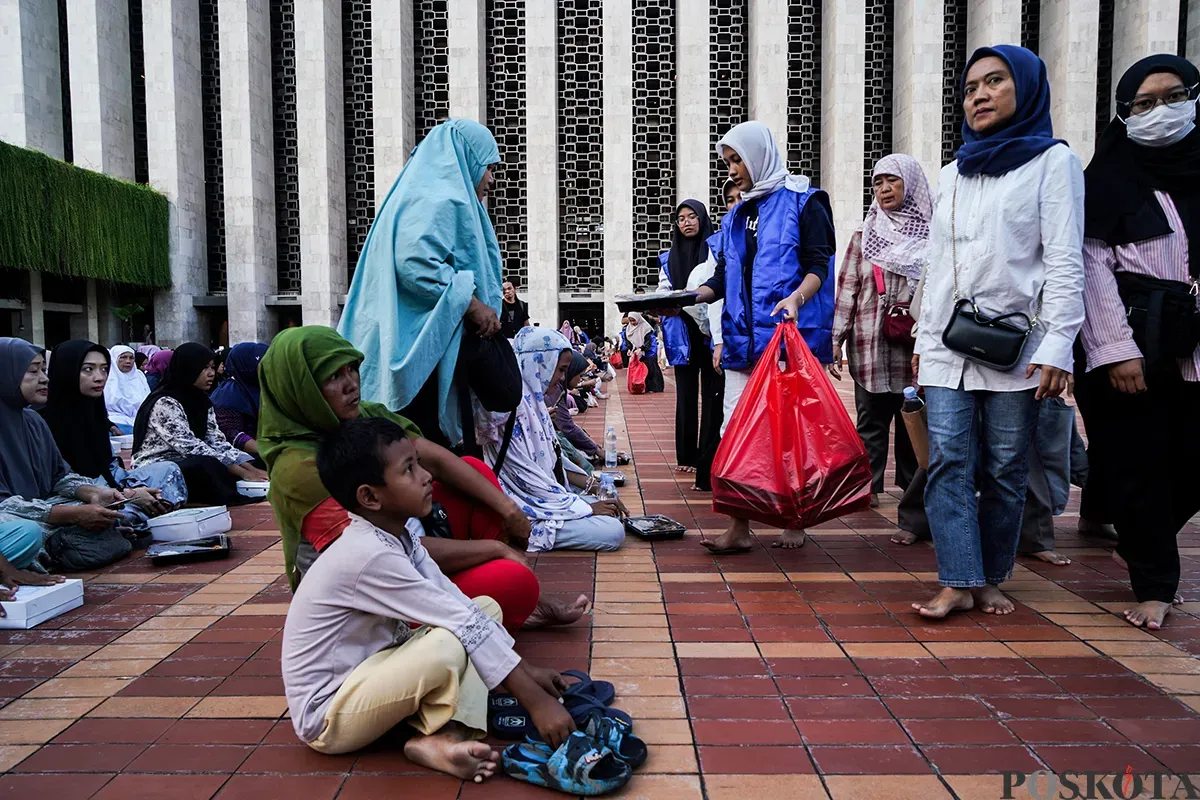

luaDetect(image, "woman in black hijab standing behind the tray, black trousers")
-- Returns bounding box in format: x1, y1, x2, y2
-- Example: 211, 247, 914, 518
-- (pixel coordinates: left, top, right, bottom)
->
659, 200, 722, 484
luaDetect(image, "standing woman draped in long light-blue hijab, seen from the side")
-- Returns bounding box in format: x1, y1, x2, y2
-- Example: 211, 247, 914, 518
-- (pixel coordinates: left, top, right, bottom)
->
337, 119, 502, 451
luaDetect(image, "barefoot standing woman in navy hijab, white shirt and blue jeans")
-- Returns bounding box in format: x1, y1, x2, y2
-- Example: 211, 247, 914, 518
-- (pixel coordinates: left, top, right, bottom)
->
913, 44, 1084, 619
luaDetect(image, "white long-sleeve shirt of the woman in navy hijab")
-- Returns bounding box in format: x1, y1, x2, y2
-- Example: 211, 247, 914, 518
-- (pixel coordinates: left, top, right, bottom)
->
916, 144, 1084, 392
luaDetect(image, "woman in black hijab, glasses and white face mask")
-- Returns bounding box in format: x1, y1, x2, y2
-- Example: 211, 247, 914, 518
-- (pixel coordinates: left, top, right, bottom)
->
1078, 55, 1200, 628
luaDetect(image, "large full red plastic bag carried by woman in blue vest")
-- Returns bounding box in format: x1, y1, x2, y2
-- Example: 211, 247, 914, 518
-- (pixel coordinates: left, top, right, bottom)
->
713, 323, 871, 529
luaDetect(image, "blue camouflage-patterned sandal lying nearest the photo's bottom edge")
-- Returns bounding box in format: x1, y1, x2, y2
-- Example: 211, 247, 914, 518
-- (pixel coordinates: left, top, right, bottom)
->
500, 730, 632, 798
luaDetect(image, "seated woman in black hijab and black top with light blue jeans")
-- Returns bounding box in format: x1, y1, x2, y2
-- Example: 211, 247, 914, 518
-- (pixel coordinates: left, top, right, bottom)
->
41, 339, 187, 529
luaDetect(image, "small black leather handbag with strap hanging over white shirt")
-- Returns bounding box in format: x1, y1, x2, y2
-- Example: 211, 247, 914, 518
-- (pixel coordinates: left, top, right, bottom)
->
942, 175, 1042, 372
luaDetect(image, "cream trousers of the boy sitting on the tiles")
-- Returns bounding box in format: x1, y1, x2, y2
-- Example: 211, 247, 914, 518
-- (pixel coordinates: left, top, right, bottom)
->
308, 597, 502, 754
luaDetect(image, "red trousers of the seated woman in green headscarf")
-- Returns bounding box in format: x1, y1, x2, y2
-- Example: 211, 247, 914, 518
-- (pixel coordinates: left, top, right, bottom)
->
433, 456, 540, 631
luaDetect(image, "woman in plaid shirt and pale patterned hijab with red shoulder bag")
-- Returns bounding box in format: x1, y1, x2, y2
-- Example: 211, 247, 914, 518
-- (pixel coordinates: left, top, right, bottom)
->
829, 154, 934, 506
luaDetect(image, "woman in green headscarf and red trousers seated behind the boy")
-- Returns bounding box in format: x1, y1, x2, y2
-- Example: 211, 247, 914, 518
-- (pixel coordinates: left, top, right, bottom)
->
258, 325, 587, 626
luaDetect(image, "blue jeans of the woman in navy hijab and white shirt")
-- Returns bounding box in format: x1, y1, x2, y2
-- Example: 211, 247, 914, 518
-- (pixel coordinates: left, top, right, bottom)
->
925, 386, 1038, 589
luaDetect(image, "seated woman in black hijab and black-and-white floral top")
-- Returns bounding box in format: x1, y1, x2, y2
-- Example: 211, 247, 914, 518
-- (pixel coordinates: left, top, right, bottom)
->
133, 342, 268, 505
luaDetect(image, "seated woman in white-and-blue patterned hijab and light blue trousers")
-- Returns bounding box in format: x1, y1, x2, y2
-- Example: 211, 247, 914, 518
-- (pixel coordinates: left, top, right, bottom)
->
475, 327, 625, 553
